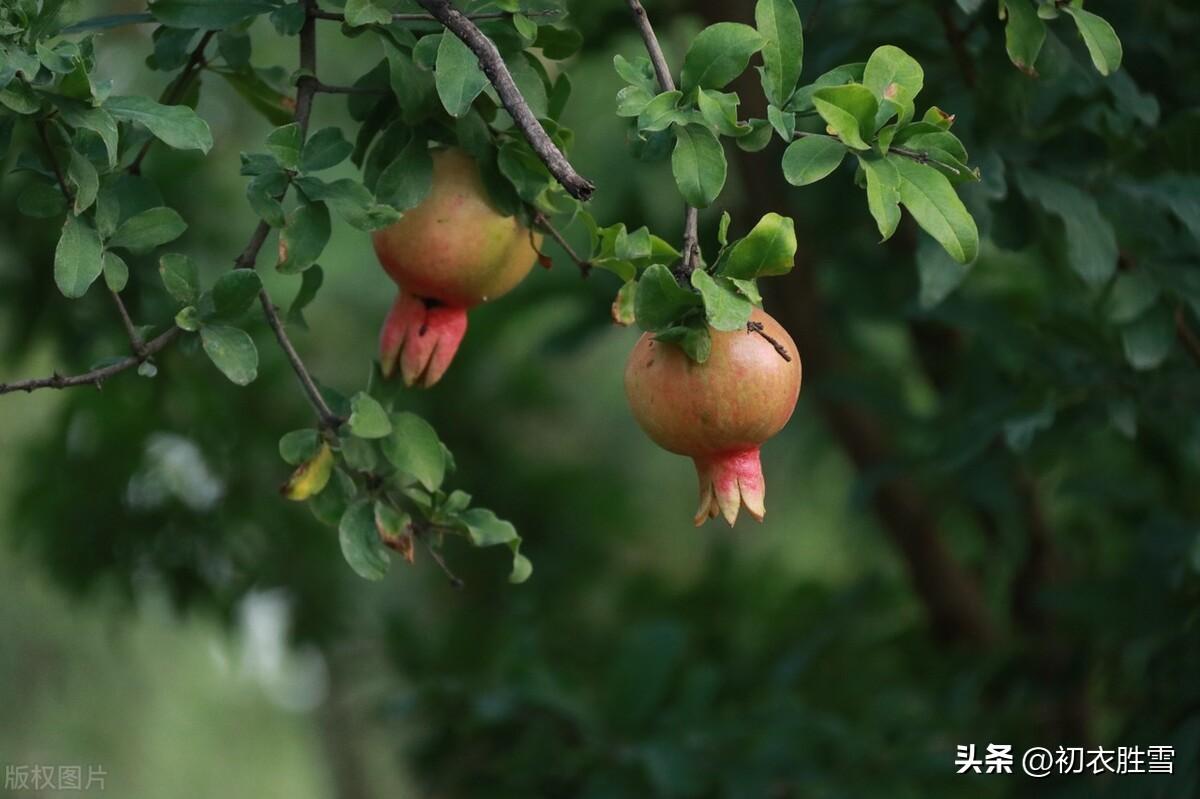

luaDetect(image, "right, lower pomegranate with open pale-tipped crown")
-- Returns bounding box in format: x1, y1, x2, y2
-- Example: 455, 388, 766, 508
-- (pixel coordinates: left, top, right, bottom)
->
625, 308, 800, 527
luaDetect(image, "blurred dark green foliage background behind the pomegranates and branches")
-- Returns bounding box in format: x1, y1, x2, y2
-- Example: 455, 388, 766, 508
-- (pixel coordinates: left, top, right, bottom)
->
0, 0, 1200, 799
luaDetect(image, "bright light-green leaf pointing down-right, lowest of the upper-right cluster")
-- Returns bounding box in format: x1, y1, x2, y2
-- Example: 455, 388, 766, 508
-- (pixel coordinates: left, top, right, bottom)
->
888, 156, 979, 264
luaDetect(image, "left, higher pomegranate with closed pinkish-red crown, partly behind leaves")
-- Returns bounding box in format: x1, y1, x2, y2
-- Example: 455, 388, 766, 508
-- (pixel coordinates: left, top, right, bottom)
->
372, 148, 541, 388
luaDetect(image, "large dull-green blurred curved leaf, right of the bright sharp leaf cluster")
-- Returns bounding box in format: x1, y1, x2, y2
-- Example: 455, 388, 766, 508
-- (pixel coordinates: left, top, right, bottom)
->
1016, 169, 1118, 286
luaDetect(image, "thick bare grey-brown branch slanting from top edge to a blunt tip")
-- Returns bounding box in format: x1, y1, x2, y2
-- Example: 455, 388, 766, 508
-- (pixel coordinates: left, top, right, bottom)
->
418, 0, 595, 200
